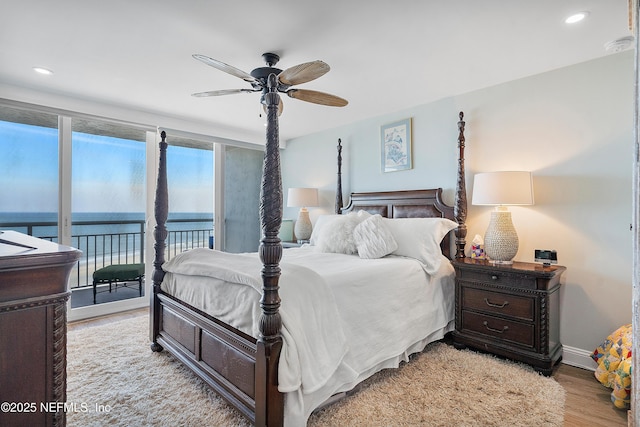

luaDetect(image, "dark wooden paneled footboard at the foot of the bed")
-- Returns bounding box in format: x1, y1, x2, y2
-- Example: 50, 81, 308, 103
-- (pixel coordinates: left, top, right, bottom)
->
152, 292, 284, 426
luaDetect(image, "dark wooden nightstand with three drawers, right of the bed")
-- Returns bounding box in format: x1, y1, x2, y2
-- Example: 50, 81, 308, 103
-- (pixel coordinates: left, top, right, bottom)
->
452, 258, 566, 376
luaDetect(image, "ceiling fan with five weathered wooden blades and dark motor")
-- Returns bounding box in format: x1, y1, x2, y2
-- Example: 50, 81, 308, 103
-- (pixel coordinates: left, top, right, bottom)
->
192, 53, 348, 115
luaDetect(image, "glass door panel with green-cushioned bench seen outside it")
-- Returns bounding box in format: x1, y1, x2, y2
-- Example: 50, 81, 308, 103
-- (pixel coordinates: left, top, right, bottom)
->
70, 118, 146, 309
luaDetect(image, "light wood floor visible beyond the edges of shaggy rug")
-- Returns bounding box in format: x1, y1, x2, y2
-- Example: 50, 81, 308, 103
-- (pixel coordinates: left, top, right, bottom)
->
68, 308, 627, 427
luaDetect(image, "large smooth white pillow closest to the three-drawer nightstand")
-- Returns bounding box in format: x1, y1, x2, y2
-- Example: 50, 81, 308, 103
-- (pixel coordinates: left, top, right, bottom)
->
383, 218, 458, 274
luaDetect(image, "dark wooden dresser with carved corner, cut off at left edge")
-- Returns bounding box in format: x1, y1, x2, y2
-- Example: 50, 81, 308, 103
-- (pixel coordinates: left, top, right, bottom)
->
0, 231, 81, 427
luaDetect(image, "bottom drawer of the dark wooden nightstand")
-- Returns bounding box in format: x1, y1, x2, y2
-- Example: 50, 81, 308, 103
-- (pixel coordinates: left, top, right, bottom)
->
462, 311, 535, 348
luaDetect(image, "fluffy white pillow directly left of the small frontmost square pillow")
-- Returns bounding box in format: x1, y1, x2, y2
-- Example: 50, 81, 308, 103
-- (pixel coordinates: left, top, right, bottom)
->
311, 211, 371, 255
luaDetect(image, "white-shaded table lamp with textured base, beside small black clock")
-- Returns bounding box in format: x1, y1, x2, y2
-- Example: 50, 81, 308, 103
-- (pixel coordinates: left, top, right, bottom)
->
471, 171, 533, 264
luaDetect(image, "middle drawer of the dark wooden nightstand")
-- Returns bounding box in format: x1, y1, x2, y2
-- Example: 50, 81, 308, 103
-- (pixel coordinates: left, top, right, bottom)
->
461, 286, 536, 321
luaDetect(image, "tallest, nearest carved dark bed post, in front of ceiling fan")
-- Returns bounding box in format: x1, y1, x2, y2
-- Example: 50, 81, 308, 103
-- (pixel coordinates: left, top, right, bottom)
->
255, 74, 284, 426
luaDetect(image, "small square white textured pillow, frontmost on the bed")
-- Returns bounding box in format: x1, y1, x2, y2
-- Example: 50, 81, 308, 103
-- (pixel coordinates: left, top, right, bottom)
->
353, 214, 398, 259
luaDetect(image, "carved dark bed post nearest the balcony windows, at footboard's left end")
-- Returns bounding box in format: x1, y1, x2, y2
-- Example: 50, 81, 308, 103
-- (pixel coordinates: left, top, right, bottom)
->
149, 131, 169, 351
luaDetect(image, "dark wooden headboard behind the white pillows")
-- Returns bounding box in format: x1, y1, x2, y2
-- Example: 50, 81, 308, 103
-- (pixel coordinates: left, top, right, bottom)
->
342, 188, 456, 259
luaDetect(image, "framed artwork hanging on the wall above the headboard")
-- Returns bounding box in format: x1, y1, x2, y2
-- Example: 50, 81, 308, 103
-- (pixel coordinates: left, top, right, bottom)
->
380, 118, 412, 172
